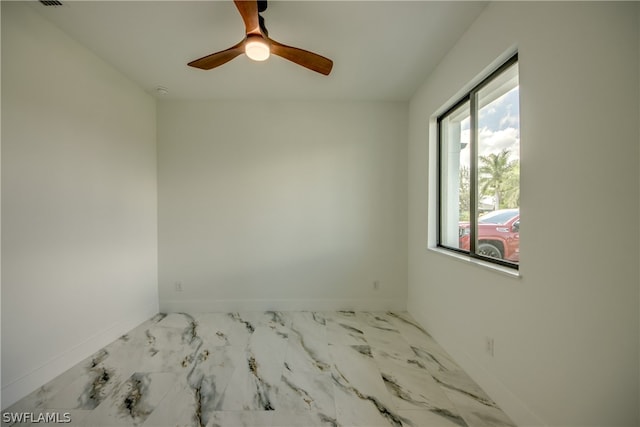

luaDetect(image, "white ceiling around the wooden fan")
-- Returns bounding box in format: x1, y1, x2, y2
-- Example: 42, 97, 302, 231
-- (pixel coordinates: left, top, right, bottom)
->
32, 0, 486, 100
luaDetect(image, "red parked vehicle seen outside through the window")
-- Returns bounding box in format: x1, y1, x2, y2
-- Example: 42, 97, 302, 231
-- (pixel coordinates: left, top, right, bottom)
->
458, 209, 520, 263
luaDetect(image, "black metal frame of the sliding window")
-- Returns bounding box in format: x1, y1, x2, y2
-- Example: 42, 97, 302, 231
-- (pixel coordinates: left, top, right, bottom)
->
436, 52, 520, 270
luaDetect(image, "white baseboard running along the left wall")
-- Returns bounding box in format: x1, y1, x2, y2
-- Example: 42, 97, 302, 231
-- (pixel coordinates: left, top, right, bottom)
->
1, 304, 158, 410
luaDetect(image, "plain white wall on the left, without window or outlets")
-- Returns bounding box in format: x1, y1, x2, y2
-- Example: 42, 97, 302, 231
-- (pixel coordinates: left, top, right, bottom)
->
2, 2, 158, 408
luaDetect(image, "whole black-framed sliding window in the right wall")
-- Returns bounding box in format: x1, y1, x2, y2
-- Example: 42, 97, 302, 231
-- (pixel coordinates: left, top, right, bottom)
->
438, 55, 520, 268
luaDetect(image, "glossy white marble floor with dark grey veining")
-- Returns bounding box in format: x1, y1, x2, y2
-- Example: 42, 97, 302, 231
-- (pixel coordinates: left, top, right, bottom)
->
3, 311, 515, 427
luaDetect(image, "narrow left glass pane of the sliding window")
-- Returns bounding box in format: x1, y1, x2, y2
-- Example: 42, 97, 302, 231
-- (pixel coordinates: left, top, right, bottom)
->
440, 102, 471, 251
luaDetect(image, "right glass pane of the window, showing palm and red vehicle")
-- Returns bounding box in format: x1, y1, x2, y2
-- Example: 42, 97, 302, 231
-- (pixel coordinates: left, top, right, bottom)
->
476, 64, 520, 263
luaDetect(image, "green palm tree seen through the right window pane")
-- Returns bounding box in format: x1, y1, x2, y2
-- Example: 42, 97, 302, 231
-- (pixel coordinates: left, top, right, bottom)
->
478, 148, 519, 209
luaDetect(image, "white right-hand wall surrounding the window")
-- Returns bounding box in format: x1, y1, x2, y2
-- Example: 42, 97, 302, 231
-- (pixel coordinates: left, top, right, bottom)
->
408, 2, 640, 426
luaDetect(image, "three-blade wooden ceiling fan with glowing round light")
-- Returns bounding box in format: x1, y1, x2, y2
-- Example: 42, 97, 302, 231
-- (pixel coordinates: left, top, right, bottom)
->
188, 0, 333, 76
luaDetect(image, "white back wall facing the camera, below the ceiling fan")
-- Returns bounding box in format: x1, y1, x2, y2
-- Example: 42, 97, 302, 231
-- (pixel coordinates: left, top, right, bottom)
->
158, 101, 408, 311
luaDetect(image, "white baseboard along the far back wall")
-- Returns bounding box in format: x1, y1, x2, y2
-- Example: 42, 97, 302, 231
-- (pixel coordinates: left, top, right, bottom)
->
160, 298, 407, 313
